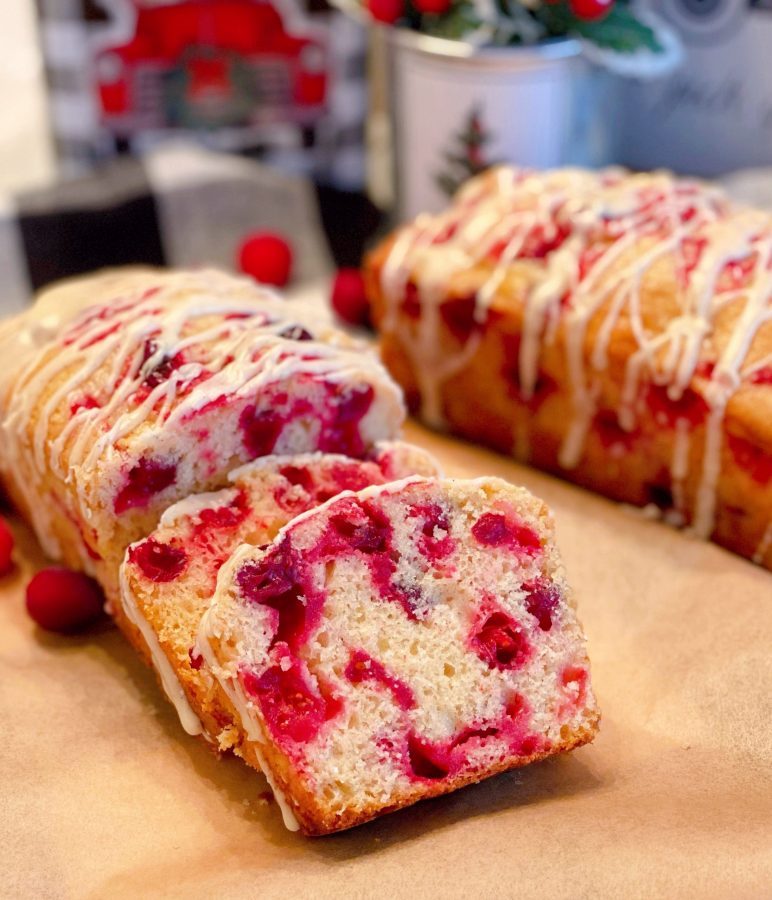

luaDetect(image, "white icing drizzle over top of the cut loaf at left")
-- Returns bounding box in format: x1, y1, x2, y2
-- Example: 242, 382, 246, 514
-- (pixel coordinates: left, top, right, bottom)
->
0, 271, 401, 571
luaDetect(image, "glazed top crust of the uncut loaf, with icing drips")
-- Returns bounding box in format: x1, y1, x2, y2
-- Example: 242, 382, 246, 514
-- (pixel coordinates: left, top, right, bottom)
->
369, 167, 772, 535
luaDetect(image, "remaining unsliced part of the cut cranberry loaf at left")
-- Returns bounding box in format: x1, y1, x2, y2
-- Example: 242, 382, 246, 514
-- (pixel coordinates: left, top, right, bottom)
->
0, 271, 403, 580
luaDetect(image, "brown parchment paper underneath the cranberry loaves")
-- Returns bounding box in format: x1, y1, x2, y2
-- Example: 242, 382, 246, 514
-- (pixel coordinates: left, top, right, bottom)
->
0, 426, 772, 900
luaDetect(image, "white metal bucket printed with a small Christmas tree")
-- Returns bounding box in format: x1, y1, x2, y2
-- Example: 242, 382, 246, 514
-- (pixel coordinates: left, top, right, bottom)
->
376, 30, 596, 221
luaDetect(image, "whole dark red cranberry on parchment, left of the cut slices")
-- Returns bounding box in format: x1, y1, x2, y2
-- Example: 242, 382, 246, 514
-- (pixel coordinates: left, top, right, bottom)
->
27, 566, 105, 634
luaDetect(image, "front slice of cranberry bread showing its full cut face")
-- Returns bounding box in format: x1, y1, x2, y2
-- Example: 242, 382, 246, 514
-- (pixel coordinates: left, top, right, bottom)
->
197, 478, 599, 835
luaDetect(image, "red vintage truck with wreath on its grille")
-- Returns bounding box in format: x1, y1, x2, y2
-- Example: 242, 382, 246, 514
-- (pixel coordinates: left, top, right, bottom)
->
95, 0, 328, 139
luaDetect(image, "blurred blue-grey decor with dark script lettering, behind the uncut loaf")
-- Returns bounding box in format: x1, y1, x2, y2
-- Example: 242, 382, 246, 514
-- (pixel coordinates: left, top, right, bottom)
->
618, 0, 772, 177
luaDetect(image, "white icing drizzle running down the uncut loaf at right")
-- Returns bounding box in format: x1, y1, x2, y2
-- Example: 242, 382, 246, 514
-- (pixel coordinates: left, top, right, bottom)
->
382, 167, 772, 537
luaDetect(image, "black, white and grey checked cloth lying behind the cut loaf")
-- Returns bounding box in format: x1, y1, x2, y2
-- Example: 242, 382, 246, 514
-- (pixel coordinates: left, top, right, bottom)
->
0, 144, 386, 316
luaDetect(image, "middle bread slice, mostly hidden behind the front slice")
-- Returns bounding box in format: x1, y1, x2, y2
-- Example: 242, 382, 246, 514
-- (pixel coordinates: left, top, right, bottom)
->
120, 442, 438, 749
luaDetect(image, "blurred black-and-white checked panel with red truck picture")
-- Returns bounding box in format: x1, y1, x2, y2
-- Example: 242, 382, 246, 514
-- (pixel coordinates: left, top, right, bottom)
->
39, 0, 366, 190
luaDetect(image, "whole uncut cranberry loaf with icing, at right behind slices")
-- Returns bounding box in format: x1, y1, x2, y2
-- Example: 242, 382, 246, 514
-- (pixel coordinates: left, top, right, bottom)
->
366, 167, 772, 568
